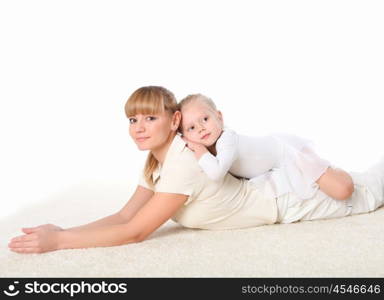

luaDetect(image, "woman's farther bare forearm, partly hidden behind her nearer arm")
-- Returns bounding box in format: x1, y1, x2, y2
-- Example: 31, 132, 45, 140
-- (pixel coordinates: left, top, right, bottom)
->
65, 185, 154, 231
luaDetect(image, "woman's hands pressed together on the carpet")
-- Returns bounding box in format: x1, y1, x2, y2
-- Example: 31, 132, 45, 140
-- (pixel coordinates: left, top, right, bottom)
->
8, 224, 63, 253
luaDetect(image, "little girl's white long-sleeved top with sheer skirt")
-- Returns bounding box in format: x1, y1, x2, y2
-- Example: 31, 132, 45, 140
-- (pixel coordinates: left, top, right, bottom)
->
198, 128, 330, 199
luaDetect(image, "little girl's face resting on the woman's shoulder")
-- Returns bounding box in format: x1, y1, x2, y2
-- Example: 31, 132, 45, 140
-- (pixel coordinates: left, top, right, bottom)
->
181, 101, 223, 147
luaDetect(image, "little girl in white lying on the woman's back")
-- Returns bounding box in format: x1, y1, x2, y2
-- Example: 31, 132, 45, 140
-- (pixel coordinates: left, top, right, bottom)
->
179, 94, 353, 200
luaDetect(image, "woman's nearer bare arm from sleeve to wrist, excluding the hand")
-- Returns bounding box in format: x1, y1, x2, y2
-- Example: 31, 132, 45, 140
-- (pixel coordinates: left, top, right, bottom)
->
57, 193, 188, 249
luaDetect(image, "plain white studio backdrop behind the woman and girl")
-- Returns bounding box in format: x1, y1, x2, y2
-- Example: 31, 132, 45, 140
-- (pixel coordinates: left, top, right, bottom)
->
0, 0, 384, 216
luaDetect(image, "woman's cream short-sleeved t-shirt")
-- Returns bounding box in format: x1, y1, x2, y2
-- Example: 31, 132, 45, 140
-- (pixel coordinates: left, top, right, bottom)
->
139, 135, 277, 230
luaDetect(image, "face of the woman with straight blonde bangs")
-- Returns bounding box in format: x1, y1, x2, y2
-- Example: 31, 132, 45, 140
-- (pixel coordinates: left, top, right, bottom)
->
129, 111, 180, 151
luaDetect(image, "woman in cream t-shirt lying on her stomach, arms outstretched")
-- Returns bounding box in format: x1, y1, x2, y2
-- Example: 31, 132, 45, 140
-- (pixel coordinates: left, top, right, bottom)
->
9, 86, 384, 253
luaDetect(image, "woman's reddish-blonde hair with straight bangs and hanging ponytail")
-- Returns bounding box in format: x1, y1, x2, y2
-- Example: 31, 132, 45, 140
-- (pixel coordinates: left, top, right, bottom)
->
124, 86, 178, 188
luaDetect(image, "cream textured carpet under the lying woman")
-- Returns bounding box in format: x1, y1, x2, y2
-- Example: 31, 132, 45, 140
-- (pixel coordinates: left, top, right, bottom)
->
0, 182, 384, 277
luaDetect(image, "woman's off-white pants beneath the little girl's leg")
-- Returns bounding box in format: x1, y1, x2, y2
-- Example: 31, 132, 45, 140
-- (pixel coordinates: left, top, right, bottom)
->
277, 169, 384, 223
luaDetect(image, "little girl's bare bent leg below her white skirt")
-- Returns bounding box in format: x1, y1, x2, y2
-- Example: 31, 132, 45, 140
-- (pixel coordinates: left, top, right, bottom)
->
316, 167, 354, 200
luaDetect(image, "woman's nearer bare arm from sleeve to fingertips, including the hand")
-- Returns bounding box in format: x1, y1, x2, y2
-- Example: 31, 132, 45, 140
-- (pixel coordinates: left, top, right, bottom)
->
8, 193, 188, 253
